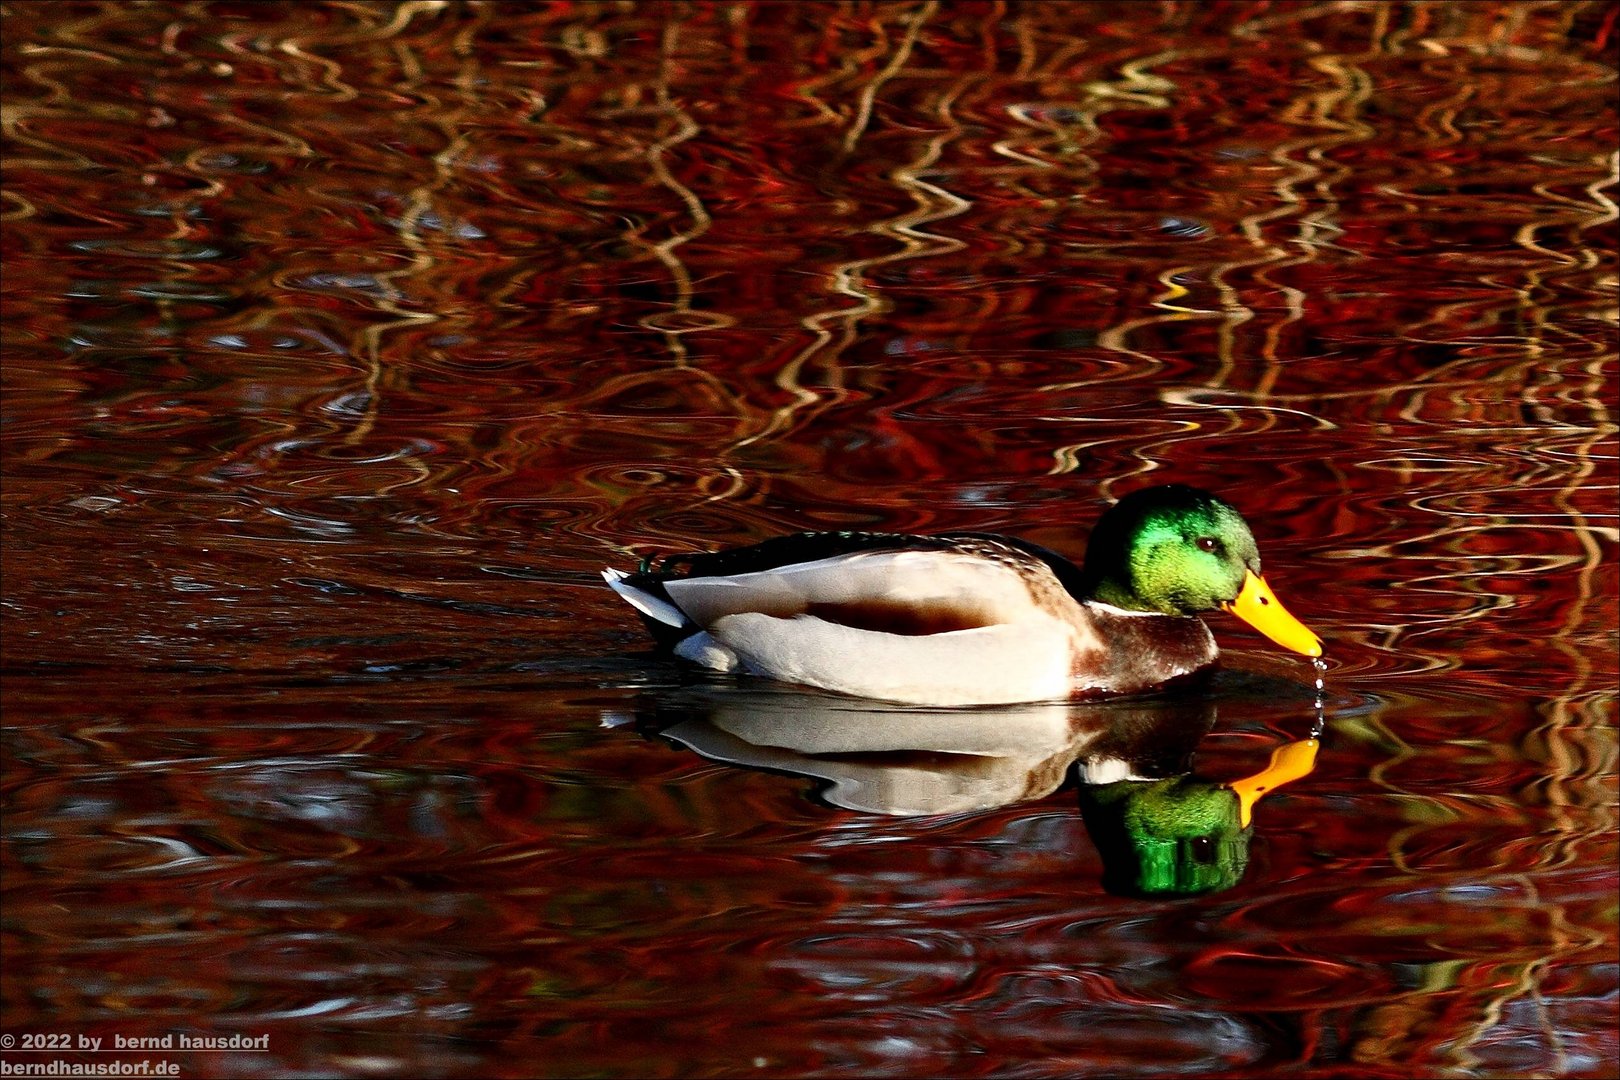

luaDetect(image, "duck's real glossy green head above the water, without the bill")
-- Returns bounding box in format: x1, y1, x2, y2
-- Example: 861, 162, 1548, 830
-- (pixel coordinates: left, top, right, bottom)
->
1085, 484, 1260, 615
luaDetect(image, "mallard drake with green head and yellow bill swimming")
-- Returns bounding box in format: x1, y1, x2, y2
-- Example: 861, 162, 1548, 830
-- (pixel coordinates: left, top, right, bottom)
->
603, 484, 1322, 706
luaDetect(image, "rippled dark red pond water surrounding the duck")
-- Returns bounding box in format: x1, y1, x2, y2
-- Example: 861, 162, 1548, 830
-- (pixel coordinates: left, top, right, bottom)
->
0, 0, 1620, 1077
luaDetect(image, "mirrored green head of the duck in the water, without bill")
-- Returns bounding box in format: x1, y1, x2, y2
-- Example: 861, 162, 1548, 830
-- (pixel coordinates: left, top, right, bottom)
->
1081, 776, 1254, 897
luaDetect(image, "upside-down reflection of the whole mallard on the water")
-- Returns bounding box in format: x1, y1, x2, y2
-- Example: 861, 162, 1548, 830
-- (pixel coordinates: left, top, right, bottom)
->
615, 688, 1317, 897
